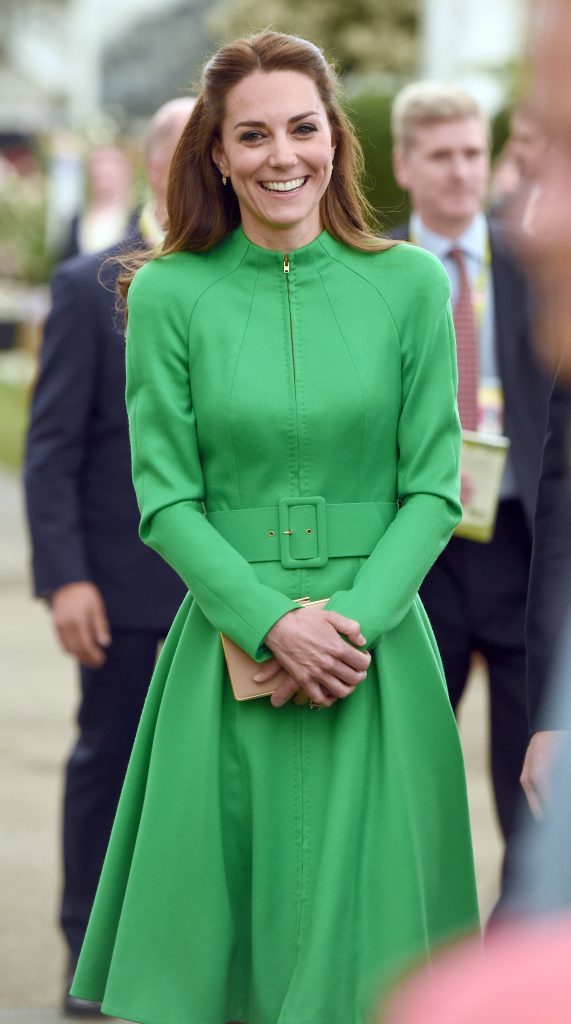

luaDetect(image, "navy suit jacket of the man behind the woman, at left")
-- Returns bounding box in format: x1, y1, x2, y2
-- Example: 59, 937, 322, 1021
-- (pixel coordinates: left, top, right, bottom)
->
25, 237, 185, 631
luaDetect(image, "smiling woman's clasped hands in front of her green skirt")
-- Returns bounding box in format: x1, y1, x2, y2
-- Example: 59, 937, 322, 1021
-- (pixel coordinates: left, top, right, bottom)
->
254, 608, 370, 708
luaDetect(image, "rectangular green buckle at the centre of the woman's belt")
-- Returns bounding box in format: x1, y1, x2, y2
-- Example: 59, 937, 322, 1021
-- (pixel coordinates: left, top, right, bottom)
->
277, 496, 328, 569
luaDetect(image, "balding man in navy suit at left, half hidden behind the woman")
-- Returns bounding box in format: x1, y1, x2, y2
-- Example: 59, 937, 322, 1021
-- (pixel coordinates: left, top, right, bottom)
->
26, 98, 193, 1016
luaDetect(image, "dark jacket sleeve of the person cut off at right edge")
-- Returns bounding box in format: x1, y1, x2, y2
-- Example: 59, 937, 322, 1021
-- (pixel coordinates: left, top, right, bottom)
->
526, 383, 571, 732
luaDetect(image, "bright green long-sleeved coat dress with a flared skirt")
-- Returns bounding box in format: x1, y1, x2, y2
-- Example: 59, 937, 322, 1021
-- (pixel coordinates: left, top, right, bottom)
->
73, 228, 478, 1024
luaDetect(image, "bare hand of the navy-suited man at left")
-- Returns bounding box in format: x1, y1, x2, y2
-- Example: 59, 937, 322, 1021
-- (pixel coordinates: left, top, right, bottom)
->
50, 583, 112, 669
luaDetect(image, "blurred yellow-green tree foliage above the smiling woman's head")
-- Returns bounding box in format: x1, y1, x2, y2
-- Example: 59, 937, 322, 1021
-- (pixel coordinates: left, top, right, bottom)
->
208, 0, 419, 74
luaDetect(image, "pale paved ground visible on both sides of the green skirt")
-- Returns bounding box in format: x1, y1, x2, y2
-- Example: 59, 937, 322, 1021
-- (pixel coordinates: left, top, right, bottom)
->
0, 473, 500, 1024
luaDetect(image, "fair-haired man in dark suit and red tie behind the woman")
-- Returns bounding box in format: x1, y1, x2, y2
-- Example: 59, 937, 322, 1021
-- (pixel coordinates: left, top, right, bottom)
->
393, 82, 550, 838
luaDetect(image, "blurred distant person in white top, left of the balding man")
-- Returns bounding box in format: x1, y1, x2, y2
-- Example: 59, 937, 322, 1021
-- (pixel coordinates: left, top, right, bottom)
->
61, 142, 137, 259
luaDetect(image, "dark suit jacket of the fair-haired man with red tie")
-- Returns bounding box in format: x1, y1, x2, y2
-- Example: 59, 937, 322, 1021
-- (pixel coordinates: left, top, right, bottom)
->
392, 221, 552, 532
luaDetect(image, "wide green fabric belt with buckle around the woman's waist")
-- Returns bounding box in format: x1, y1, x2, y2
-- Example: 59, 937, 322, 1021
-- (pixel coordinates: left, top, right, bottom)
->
206, 496, 397, 569
